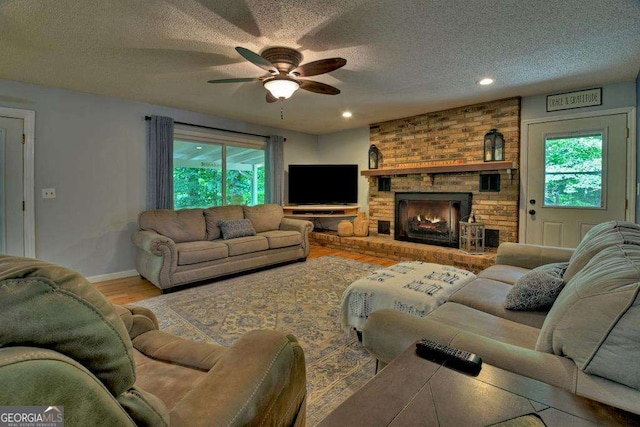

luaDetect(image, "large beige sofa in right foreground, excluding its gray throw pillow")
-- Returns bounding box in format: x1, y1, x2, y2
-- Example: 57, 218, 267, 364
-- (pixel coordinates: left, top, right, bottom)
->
363, 222, 640, 413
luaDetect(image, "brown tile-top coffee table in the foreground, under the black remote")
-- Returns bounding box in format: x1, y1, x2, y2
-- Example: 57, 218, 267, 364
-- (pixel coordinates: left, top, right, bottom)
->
319, 346, 640, 427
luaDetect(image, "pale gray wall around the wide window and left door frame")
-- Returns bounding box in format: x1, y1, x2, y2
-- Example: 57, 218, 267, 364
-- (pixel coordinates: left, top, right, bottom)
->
0, 80, 318, 276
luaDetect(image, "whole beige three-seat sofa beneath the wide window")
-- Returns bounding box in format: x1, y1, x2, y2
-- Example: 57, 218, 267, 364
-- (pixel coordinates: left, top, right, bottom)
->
132, 204, 313, 292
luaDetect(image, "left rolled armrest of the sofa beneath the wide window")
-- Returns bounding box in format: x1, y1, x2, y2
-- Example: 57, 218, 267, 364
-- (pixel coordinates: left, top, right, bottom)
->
131, 230, 178, 289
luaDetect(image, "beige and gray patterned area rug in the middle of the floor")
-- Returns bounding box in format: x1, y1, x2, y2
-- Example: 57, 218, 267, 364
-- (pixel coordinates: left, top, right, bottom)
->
136, 256, 381, 426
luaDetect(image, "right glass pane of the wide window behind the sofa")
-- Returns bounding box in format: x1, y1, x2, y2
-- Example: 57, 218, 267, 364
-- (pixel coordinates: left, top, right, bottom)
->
227, 146, 264, 205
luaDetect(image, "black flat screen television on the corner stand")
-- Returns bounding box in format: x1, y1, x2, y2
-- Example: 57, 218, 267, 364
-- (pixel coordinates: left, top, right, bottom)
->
289, 164, 358, 205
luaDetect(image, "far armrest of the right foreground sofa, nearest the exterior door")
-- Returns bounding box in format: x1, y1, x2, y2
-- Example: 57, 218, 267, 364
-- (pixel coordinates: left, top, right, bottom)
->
496, 243, 574, 269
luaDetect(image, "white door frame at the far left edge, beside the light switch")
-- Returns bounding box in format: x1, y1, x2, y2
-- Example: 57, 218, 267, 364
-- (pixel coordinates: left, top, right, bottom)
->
0, 107, 36, 258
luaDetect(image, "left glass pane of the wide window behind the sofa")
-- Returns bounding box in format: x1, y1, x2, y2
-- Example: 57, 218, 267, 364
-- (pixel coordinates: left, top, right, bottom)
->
173, 140, 223, 209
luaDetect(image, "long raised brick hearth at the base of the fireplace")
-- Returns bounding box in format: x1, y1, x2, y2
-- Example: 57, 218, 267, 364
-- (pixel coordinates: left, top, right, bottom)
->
309, 231, 496, 273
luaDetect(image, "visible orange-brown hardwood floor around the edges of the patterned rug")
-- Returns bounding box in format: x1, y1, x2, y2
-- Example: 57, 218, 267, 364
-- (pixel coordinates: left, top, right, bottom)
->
94, 246, 398, 304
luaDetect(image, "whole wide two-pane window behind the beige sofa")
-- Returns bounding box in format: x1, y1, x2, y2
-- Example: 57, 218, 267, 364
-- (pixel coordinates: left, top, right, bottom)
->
173, 130, 266, 209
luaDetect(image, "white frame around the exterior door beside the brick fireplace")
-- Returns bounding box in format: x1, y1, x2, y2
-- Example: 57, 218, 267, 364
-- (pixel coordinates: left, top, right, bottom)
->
518, 107, 636, 242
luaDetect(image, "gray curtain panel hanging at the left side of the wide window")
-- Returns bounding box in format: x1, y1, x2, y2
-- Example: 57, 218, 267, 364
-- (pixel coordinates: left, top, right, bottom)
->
147, 116, 173, 209
